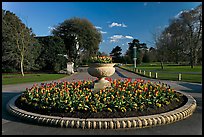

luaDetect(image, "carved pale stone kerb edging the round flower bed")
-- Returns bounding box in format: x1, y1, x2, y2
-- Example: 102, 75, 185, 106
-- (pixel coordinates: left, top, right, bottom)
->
6, 91, 197, 129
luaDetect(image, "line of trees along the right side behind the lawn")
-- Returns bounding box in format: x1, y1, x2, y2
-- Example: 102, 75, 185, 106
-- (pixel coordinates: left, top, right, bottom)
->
110, 5, 202, 68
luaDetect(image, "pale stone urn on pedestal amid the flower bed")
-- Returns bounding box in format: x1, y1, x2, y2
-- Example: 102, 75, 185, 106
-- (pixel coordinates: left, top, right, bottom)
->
88, 63, 115, 92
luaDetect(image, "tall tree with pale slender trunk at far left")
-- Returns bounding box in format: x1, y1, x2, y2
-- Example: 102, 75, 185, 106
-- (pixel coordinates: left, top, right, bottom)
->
2, 10, 39, 76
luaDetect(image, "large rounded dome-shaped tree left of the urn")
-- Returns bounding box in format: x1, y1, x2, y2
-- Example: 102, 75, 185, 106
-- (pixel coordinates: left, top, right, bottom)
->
52, 18, 102, 63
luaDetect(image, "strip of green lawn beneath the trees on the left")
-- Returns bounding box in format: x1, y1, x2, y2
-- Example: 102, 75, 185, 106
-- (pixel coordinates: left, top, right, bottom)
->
2, 73, 68, 85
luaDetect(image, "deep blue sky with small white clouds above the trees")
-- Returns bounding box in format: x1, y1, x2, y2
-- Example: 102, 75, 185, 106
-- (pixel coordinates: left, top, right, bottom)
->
2, 2, 201, 54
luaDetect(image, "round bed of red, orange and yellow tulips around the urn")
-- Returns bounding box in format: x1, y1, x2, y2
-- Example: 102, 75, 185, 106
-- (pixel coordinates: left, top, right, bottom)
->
15, 79, 187, 118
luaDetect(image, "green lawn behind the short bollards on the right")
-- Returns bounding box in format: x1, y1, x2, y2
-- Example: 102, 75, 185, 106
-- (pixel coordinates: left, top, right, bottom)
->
121, 63, 202, 83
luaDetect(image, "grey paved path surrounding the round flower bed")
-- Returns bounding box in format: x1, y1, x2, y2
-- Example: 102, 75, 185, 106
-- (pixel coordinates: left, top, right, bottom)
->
2, 68, 202, 135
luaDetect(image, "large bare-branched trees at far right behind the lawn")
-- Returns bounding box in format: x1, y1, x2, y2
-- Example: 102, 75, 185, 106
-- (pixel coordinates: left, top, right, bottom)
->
155, 5, 202, 68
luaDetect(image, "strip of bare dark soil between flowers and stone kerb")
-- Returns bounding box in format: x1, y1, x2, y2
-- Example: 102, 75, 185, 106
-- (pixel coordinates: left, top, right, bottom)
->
15, 95, 188, 119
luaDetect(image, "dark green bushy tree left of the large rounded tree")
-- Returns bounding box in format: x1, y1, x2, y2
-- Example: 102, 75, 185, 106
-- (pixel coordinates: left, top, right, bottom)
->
36, 36, 67, 72
